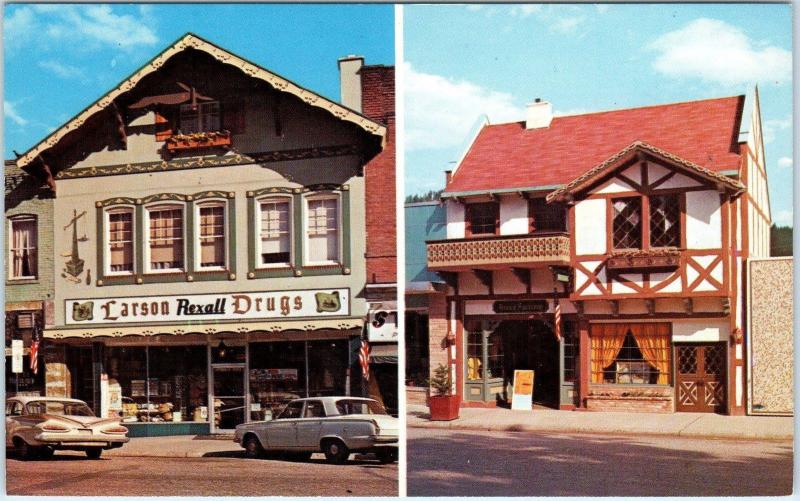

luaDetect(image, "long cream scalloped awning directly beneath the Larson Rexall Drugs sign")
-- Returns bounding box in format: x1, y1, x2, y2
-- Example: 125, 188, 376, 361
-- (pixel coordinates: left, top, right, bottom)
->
44, 318, 364, 340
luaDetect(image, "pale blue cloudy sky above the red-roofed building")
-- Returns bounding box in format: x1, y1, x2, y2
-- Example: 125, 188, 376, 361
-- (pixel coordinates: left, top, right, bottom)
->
403, 4, 793, 224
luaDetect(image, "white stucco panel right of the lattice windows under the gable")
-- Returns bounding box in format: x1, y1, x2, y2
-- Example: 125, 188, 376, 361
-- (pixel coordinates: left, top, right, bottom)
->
686, 190, 722, 249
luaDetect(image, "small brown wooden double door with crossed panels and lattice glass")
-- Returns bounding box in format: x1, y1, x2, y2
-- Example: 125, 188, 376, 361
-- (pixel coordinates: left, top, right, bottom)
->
675, 343, 726, 412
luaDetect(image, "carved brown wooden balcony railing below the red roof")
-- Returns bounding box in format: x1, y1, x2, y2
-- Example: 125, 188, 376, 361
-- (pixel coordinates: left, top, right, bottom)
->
428, 233, 570, 271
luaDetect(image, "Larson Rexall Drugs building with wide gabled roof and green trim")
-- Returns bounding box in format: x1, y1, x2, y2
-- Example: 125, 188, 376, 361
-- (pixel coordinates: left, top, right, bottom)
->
11, 34, 386, 435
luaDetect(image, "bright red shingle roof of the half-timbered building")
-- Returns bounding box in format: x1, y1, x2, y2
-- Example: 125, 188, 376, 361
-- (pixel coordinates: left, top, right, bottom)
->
445, 96, 744, 193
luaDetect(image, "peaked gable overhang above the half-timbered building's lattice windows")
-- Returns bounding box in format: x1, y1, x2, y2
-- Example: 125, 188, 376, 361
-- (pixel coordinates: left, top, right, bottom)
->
547, 141, 745, 202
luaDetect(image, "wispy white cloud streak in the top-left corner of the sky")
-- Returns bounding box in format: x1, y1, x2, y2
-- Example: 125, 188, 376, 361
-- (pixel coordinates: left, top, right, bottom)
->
4, 4, 158, 50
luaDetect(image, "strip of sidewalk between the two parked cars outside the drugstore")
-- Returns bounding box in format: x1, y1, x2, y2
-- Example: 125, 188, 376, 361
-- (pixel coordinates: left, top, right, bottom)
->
108, 435, 244, 458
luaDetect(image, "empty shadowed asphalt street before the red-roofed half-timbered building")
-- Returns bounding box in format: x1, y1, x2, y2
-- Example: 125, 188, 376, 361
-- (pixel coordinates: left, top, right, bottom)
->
408, 428, 792, 496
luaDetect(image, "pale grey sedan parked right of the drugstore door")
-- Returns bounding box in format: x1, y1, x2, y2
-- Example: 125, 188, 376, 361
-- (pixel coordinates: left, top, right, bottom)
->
234, 397, 399, 463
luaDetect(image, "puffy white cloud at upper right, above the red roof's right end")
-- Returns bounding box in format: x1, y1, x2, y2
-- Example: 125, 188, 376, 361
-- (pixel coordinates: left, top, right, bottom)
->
649, 18, 792, 86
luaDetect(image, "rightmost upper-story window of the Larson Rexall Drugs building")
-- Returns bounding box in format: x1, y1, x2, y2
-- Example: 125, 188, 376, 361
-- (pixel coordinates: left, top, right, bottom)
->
306, 195, 340, 264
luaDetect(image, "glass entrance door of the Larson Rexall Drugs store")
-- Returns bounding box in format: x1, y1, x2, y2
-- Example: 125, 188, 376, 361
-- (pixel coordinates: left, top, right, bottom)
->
209, 364, 247, 433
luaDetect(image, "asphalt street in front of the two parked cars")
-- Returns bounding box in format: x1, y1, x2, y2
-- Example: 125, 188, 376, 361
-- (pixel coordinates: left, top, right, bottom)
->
6, 451, 398, 496
